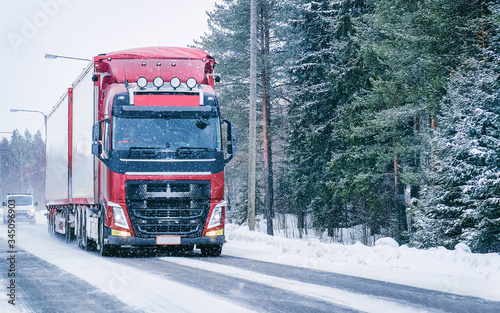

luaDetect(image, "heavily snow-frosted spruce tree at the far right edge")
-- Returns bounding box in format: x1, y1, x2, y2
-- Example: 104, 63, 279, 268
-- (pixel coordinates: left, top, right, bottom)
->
416, 1, 500, 252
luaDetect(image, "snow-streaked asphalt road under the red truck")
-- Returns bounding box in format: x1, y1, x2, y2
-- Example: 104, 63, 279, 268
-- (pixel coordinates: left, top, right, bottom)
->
0, 217, 500, 312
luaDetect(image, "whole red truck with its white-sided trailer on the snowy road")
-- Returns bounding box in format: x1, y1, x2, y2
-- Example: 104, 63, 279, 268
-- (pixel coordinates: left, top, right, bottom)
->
45, 47, 236, 256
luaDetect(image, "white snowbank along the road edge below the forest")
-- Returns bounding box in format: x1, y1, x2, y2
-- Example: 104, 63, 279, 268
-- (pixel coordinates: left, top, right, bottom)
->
223, 225, 500, 301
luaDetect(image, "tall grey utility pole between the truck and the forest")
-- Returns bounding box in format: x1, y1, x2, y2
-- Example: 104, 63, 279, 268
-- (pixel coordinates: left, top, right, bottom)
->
247, 0, 257, 230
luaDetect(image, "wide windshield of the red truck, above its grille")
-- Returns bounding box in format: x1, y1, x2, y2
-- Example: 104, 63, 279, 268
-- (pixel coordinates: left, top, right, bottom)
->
111, 117, 222, 151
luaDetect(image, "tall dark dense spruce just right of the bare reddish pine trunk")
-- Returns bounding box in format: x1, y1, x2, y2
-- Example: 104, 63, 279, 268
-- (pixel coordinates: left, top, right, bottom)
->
286, 0, 338, 236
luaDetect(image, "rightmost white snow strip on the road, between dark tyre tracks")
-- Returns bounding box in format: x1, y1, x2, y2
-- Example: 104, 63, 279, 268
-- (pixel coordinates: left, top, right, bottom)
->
165, 257, 429, 313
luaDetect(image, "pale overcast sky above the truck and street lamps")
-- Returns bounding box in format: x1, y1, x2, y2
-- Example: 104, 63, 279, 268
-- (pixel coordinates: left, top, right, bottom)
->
0, 0, 216, 138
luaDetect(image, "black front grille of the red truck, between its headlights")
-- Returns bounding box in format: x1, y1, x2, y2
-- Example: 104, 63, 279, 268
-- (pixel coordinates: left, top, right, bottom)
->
126, 181, 210, 238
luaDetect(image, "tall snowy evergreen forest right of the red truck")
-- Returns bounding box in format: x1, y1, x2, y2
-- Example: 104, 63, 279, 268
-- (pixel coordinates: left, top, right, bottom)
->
196, 0, 500, 252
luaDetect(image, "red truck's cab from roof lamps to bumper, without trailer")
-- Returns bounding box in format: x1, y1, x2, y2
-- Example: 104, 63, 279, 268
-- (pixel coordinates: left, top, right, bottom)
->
93, 75, 236, 255
